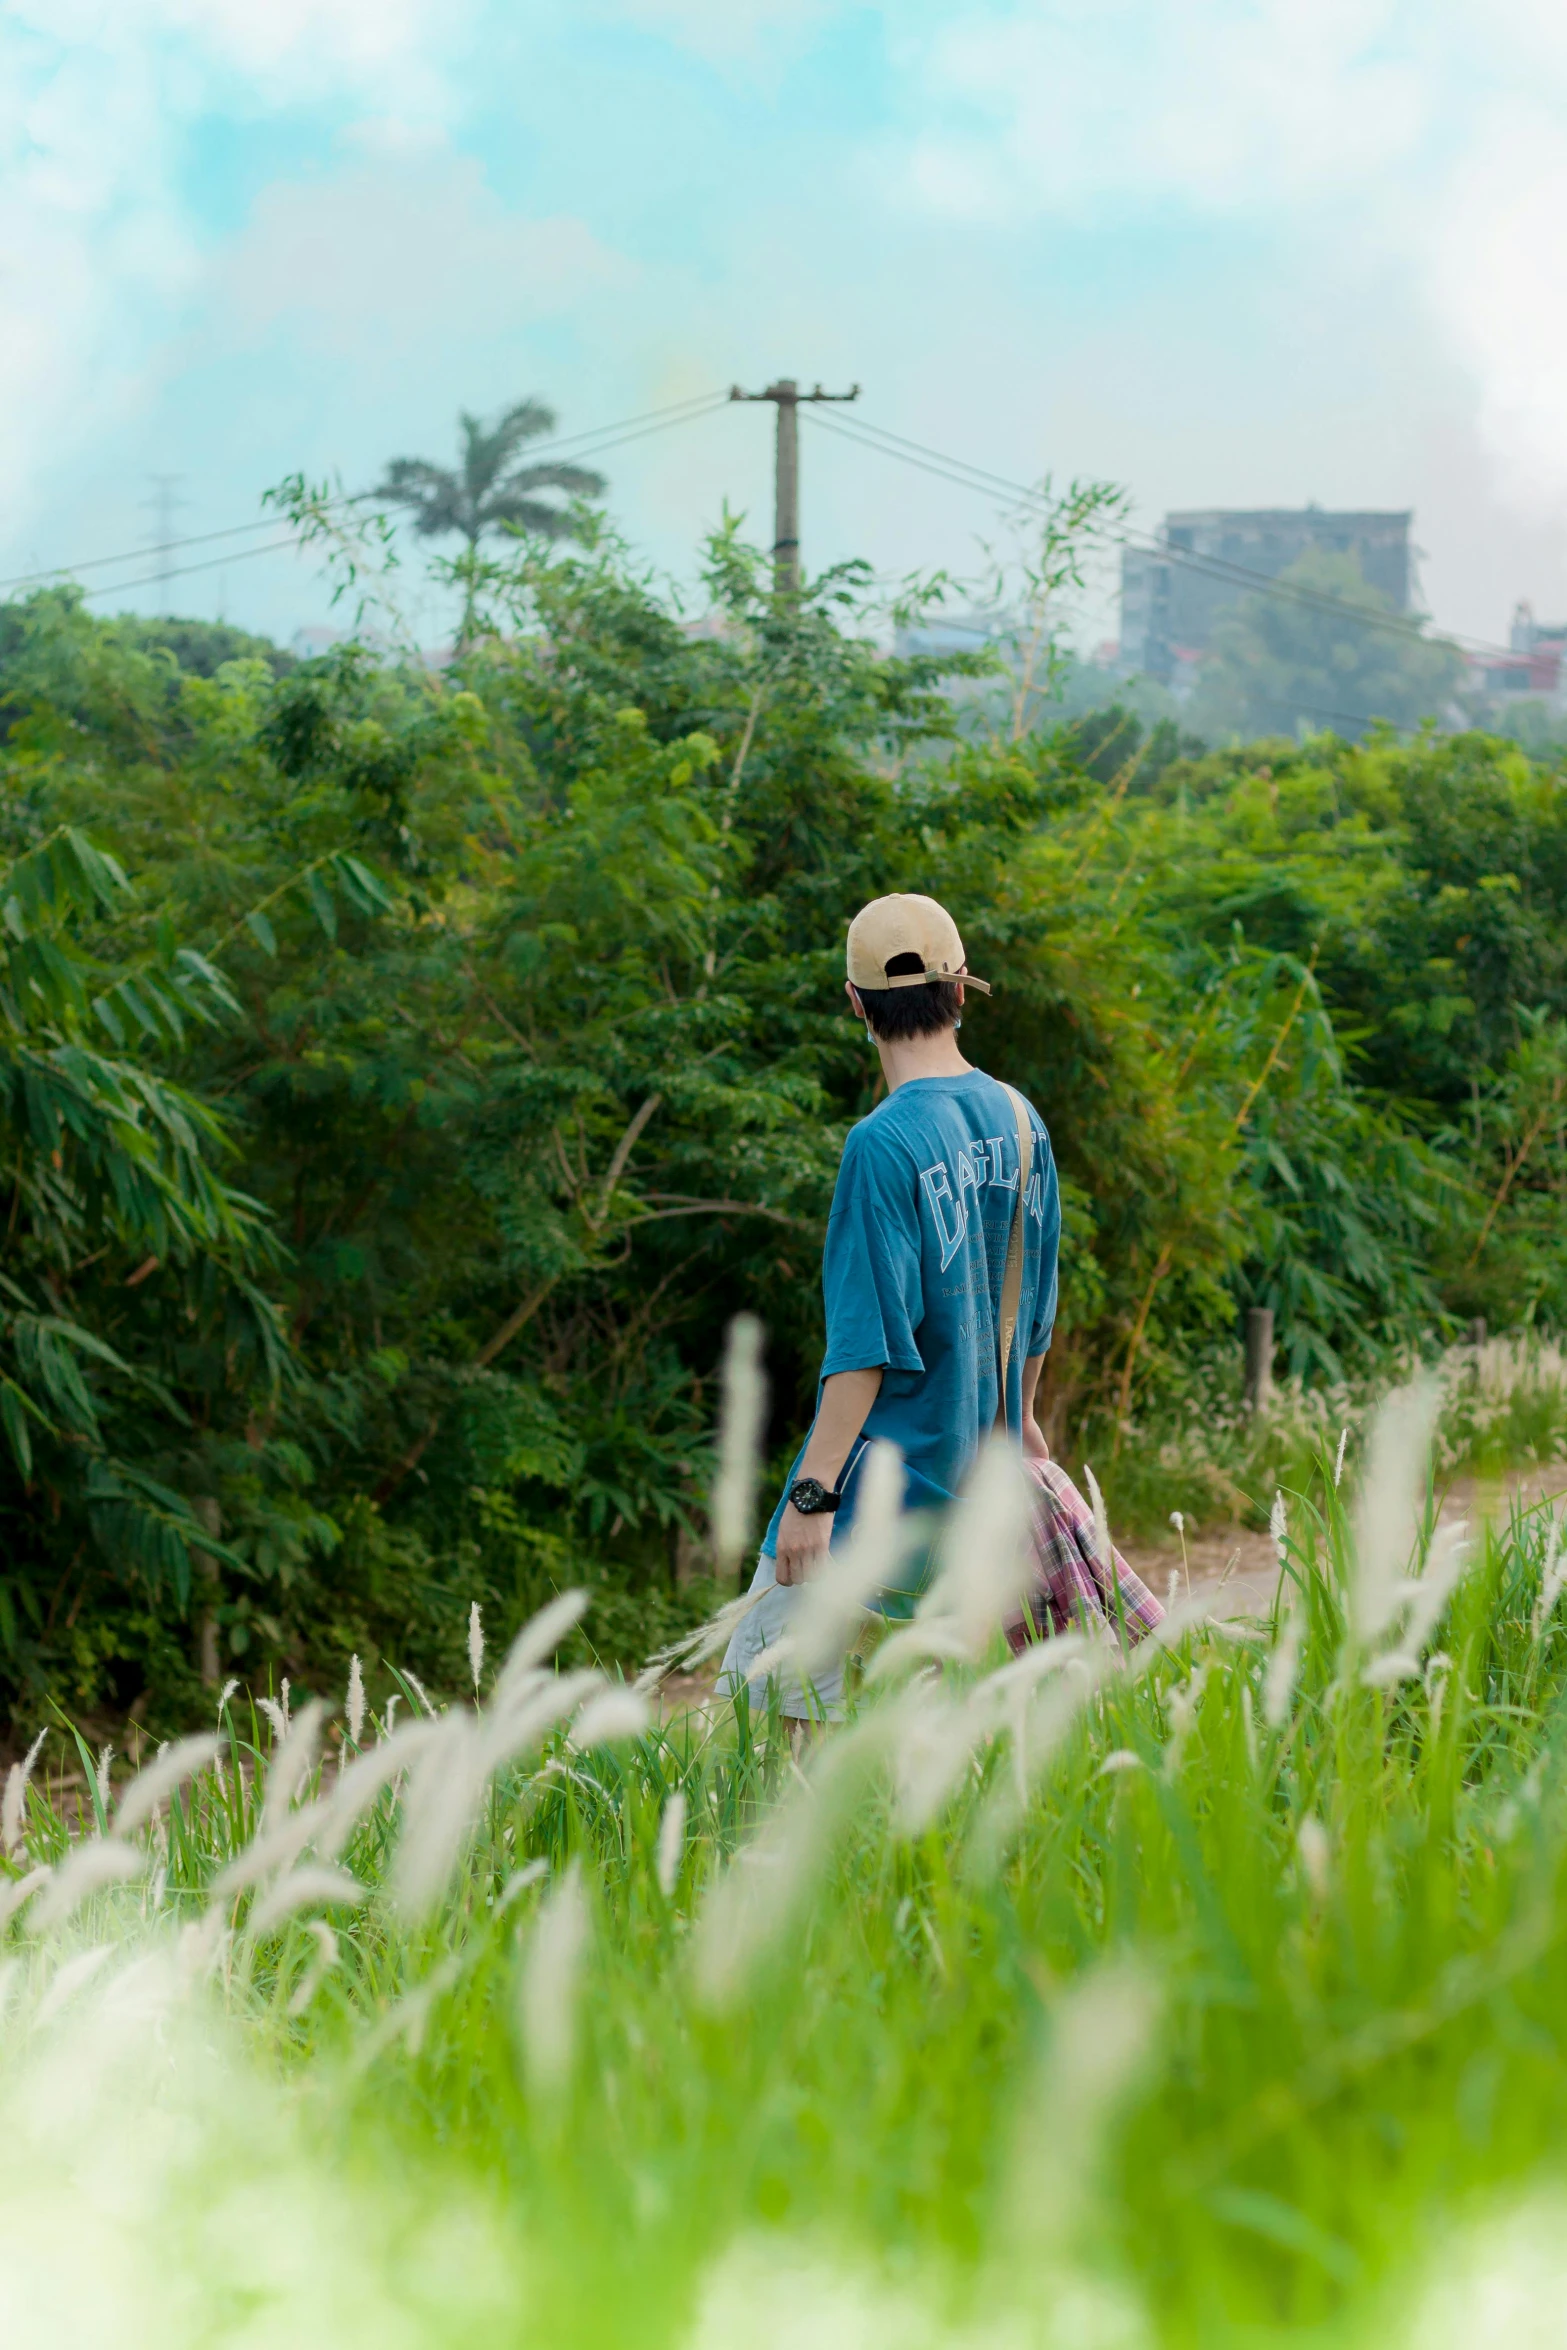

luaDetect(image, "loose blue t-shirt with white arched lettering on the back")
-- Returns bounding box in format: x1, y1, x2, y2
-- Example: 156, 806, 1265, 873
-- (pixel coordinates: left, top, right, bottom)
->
761, 1069, 1062, 1556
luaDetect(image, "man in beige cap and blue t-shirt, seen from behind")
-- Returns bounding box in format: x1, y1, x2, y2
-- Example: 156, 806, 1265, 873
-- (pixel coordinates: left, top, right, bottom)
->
719, 895, 1062, 1718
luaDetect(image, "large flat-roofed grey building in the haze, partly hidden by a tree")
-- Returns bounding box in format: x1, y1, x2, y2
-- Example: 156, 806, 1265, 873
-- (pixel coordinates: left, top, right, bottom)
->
1121, 505, 1414, 686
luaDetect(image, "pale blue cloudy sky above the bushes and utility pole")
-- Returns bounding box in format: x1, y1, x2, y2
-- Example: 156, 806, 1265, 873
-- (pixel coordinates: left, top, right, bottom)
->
0, 0, 1567, 639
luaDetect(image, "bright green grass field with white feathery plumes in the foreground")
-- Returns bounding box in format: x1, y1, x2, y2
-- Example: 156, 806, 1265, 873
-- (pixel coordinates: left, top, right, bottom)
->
0, 1394, 1567, 2350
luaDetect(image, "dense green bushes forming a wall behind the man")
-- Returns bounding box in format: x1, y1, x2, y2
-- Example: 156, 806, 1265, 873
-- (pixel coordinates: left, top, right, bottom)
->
0, 533, 1567, 1713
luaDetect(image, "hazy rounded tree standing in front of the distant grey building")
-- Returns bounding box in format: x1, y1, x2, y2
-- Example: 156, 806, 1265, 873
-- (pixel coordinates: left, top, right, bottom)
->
1186, 550, 1464, 743
